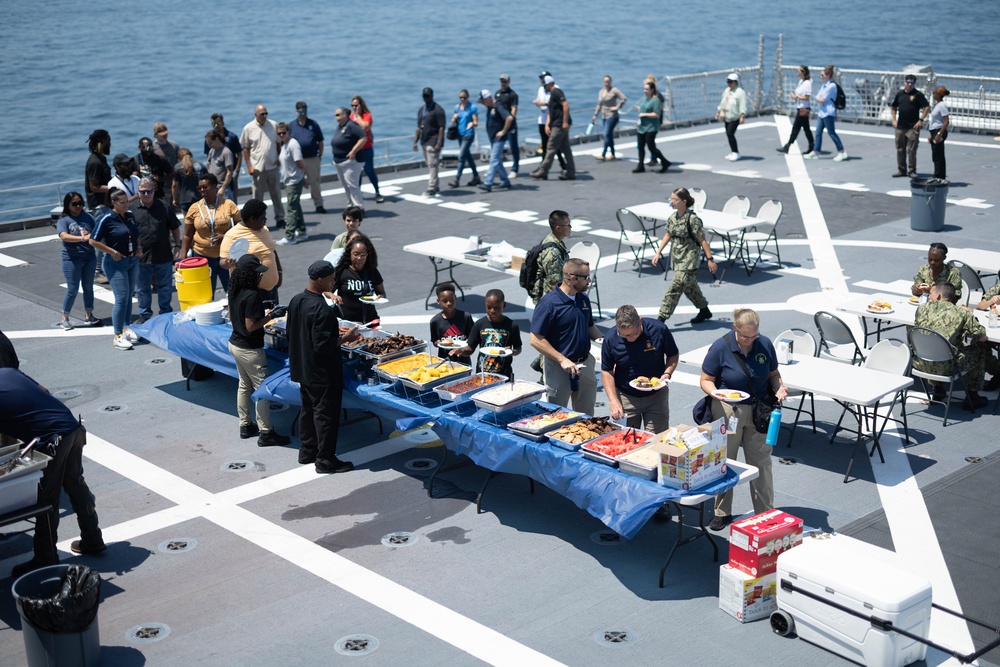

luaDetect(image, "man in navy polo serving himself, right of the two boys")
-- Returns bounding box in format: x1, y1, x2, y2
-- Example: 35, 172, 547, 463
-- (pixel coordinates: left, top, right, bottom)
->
531, 258, 601, 415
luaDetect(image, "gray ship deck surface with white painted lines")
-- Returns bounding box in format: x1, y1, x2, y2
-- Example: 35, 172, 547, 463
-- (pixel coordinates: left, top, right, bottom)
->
0, 117, 1000, 666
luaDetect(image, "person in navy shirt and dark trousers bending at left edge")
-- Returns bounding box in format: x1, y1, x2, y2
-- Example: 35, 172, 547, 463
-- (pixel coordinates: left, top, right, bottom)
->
0, 368, 107, 577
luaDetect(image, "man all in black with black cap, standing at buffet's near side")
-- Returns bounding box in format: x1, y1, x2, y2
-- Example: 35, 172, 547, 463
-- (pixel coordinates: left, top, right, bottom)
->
287, 260, 358, 474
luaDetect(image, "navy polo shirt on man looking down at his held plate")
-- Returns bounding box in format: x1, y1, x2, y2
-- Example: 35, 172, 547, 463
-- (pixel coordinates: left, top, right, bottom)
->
601, 317, 679, 396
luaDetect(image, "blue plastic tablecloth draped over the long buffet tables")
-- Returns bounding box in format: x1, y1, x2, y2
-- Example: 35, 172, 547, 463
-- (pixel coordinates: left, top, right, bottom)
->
132, 314, 739, 538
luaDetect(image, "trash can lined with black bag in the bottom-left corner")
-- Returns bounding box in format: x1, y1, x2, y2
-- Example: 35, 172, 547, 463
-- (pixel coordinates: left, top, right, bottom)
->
11, 565, 101, 667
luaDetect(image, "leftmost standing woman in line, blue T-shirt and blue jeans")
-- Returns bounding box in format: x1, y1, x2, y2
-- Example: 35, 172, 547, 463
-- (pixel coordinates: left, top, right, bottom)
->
56, 192, 103, 331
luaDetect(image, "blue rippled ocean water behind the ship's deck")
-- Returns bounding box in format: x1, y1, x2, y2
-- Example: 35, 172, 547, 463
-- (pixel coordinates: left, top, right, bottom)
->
0, 0, 1000, 219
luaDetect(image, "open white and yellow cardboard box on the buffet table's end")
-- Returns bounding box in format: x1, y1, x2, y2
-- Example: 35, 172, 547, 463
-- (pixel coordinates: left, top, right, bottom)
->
649, 418, 726, 491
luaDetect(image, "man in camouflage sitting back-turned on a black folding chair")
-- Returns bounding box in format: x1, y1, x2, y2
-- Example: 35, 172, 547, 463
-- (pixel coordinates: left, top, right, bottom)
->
913, 283, 996, 412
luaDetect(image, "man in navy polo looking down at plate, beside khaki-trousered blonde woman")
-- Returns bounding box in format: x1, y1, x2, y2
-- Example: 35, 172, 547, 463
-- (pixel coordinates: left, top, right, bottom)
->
601, 305, 680, 433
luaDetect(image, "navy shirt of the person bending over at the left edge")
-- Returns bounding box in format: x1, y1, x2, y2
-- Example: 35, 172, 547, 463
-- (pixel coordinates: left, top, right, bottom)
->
0, 368, 80, 442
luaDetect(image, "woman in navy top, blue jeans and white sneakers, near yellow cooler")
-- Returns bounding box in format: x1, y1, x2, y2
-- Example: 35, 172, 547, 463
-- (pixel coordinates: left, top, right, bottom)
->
90, 188, 142, 350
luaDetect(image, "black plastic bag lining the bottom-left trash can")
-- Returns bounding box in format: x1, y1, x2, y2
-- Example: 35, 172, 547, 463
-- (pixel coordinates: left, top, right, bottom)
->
17, 565, 101, 634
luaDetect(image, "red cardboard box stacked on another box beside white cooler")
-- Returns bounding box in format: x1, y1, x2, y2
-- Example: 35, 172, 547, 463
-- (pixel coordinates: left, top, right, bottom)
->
729, 510, 802, 577
